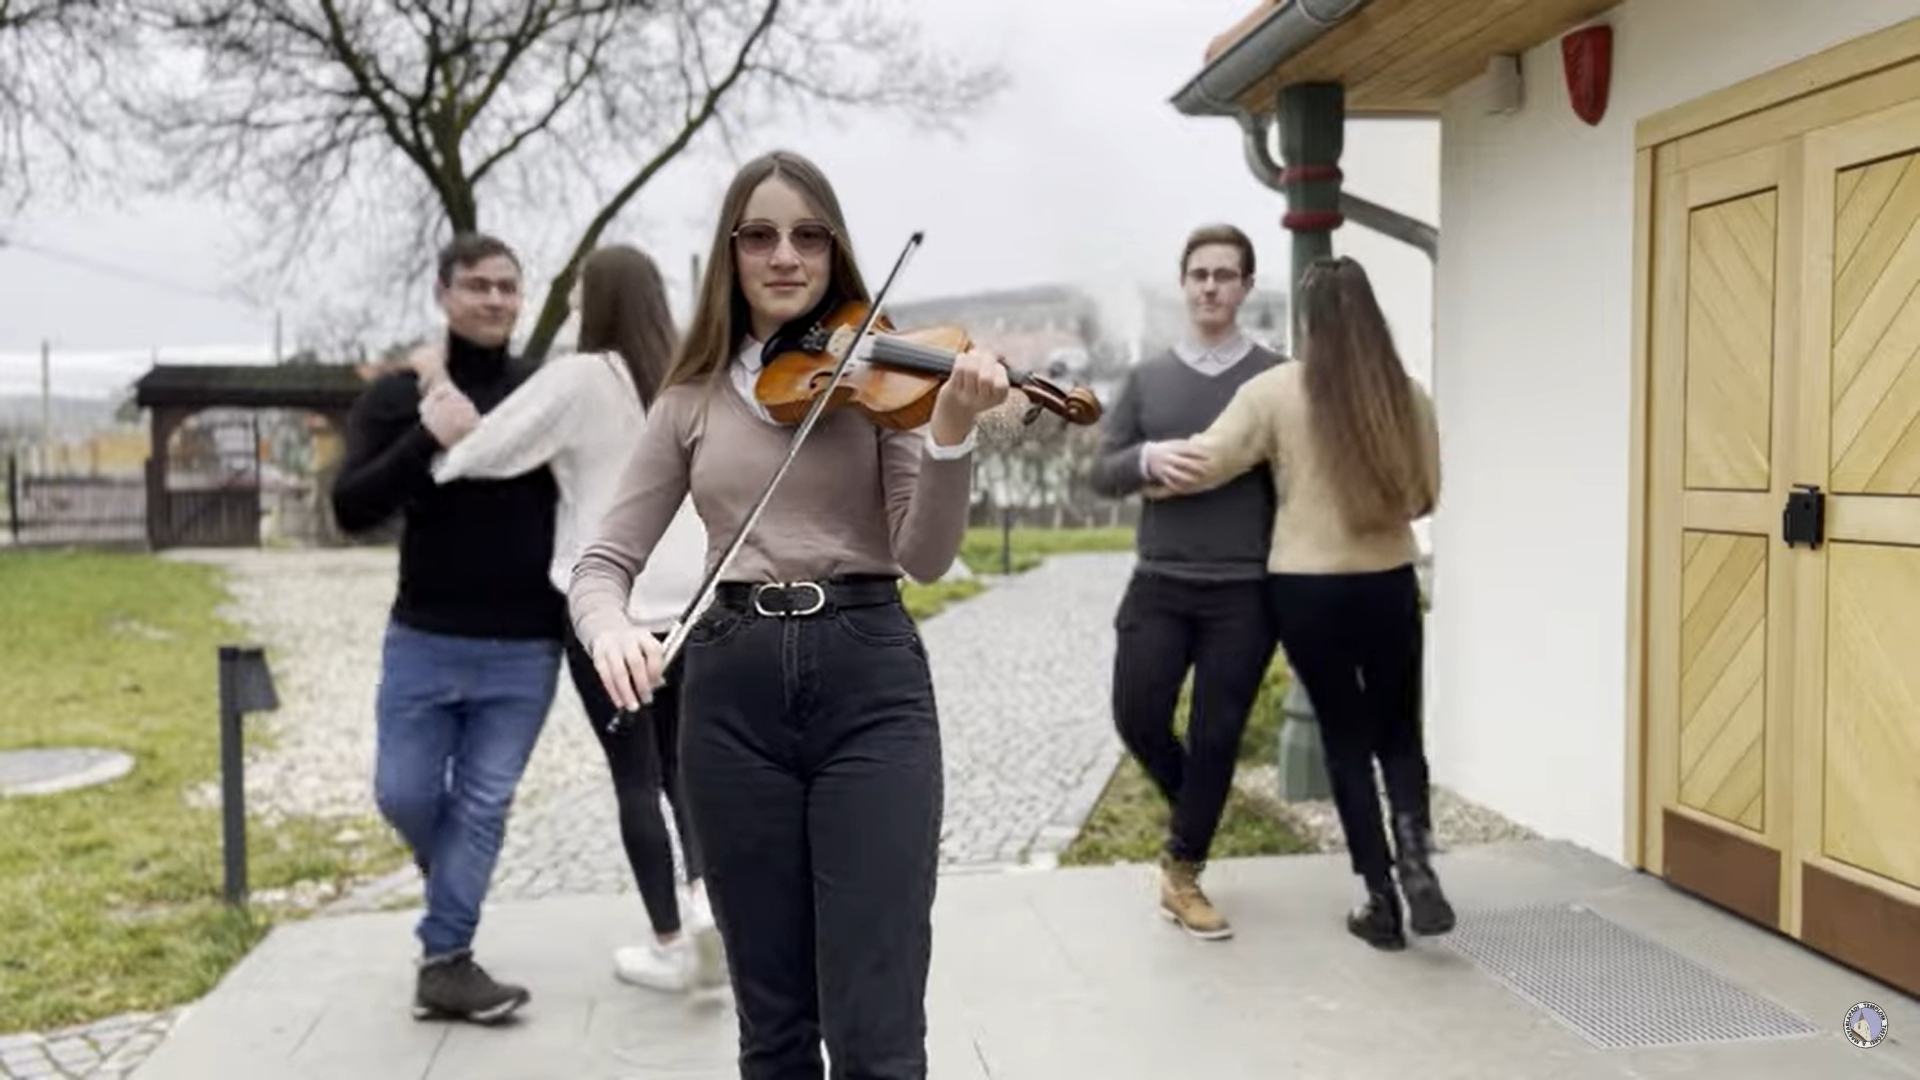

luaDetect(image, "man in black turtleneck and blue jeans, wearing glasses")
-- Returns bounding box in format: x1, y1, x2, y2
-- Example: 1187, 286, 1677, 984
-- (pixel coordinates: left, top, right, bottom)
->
332, 234, 566, 1024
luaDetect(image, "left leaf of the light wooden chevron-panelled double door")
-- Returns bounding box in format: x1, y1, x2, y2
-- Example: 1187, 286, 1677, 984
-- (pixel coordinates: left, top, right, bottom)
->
1642, 142, 1803, 926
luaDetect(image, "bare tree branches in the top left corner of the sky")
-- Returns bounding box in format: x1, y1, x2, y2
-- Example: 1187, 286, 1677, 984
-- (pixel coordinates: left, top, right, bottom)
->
0, 0, 131, 209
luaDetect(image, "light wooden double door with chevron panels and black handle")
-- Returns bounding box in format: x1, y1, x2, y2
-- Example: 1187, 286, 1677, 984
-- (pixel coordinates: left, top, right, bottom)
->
1642, 50, 1920, 994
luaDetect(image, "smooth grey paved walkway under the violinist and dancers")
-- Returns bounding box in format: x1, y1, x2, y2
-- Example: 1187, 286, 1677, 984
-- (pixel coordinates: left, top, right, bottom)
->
134, 842, 1920, 1080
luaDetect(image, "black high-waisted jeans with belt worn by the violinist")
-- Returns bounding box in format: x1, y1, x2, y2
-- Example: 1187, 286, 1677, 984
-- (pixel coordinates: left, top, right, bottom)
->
684, 578, 943, 1080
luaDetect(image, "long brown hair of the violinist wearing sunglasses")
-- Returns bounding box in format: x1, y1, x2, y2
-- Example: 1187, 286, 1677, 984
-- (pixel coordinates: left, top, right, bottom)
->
666, 150, 872, 386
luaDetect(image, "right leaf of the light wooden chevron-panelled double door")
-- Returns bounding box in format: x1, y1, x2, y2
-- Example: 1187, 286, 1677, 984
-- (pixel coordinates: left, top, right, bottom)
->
1789, 102, 1920, 994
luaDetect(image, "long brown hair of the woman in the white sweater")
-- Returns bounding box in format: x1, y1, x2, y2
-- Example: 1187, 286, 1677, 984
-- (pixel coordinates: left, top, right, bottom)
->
578, 244, 680, 409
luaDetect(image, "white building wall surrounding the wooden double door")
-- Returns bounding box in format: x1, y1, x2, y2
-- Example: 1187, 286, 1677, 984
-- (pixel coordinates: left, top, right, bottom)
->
1428, 0, 1920, 861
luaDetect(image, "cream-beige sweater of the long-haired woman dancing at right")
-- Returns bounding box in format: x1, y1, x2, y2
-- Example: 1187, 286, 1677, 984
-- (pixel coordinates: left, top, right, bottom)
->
1148, 363, 1440, 575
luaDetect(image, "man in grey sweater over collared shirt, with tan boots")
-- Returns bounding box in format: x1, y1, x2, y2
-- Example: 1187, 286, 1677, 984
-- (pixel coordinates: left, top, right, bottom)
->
1092, 225, 1283, 940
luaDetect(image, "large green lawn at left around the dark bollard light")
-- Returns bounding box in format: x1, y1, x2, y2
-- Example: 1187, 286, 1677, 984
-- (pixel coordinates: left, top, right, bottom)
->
0, 552, 405, 1032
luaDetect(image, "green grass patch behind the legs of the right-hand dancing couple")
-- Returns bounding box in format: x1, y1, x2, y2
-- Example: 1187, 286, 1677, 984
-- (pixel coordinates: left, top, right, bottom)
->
1060, 641, 1311, 867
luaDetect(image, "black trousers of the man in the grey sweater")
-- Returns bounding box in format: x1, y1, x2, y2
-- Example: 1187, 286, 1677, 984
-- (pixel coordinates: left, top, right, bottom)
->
1114, 573, 1275, 863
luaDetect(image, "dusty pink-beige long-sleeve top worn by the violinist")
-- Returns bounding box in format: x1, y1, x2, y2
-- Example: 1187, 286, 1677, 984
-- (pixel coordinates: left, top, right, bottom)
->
568, 342, 973, 648
